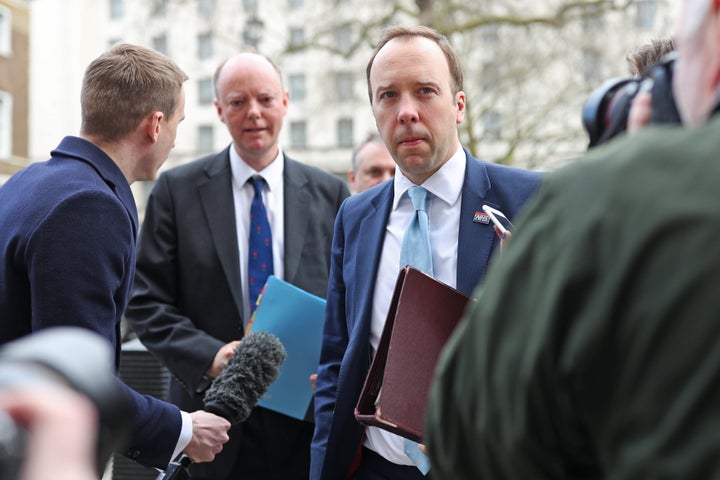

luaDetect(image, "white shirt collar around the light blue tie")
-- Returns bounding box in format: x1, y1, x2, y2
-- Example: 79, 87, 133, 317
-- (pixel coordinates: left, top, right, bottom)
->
393, 144, 466, 210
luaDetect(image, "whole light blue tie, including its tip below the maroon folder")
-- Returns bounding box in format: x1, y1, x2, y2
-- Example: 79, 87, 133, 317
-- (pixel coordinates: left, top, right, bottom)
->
400, 186, 433, 475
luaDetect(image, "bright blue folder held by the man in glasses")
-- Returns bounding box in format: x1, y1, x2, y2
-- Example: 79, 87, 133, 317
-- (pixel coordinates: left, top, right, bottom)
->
248, 276, 326, 421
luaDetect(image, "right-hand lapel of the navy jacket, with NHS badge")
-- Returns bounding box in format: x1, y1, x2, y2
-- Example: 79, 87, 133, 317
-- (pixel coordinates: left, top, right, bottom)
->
457, 152, 496, 295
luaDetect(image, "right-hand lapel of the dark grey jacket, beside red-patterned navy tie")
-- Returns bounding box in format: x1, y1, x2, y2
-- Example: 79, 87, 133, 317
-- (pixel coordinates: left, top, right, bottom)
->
283, 157, 311, 283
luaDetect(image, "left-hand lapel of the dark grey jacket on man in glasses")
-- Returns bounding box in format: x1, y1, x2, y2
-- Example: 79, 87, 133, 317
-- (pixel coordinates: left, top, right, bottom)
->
197, 149, 243, 319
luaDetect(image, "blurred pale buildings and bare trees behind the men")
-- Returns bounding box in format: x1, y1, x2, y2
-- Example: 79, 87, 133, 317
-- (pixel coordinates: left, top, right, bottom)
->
0, 0, 677, 213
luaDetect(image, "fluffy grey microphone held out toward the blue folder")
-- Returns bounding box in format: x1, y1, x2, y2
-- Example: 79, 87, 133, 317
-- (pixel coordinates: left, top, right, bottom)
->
157, 332, 287, 480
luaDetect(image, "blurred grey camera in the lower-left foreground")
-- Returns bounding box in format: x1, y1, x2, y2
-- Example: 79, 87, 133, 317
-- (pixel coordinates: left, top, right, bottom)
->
0, 327, 129, 480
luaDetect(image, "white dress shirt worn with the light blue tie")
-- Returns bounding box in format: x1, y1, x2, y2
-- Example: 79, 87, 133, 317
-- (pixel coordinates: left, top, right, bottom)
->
365, 145, 467, 465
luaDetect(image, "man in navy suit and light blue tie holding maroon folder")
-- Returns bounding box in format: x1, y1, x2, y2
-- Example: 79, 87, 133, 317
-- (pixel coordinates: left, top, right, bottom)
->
310, 27, 540, 480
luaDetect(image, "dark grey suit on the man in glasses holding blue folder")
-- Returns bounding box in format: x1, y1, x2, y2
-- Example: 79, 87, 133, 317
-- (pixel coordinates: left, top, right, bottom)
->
126, 148, 349, 479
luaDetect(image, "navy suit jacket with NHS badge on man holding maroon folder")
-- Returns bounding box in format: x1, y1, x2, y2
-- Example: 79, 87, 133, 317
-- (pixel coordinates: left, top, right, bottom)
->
310, 148, 540, 480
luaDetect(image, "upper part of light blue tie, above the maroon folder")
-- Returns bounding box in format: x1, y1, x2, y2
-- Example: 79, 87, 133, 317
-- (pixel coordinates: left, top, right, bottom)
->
400, 186, 433, 276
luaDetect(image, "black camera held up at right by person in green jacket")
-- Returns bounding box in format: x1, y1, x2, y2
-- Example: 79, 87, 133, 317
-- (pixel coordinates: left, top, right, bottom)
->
582, 52, 681, 148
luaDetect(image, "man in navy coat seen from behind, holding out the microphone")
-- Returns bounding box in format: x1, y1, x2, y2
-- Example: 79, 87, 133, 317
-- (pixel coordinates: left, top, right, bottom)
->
0, 45, 230, 469
